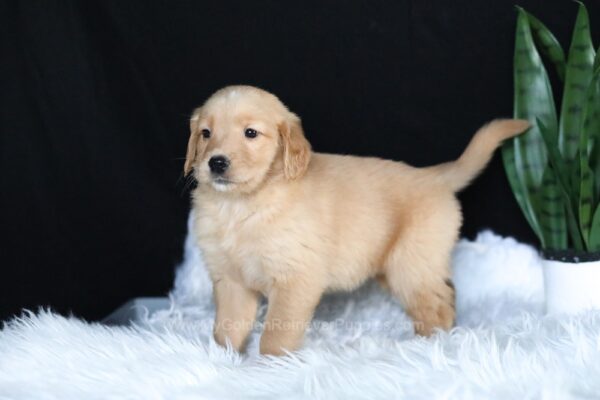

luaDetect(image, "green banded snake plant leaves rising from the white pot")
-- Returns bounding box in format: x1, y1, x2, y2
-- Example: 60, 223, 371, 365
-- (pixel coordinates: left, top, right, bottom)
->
502, 3, 600, 252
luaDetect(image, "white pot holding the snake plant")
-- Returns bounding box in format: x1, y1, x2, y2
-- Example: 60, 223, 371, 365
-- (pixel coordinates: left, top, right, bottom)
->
544, 260, 600, 314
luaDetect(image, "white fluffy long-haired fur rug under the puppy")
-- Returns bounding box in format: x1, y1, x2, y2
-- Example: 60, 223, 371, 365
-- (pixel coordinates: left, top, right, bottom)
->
0, 220, 600, 399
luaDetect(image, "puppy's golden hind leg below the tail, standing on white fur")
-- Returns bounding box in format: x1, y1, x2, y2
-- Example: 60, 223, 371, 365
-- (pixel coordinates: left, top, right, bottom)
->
384, 198, 460, 336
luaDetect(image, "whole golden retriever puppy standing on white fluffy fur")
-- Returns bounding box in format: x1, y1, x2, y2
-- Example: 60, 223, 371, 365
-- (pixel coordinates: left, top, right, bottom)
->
184, 86, 528, 355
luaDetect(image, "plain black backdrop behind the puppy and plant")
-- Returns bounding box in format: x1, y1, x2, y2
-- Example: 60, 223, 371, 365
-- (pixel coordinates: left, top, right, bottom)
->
0, 0, 600, 319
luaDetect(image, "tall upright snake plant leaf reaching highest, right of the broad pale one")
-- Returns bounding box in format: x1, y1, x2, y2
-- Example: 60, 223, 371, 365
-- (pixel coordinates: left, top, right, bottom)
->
558, 3, 595, 162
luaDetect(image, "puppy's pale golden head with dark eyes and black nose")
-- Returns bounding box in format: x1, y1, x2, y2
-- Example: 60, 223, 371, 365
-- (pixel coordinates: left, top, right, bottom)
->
184, 86, 311, 193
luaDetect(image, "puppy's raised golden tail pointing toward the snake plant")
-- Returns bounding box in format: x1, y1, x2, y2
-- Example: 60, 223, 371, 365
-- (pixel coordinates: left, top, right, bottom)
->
426, 119, 529, 192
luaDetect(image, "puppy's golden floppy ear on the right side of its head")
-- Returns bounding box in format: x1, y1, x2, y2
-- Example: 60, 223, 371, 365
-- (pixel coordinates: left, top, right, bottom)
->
279, 113, 311, 179
